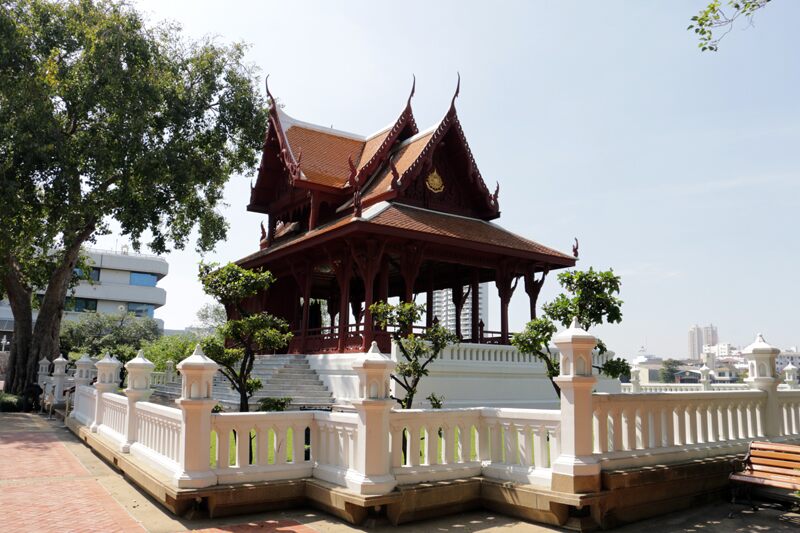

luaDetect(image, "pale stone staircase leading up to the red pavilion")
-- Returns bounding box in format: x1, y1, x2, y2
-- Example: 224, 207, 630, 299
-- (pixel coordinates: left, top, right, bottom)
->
154, 355, 334, 410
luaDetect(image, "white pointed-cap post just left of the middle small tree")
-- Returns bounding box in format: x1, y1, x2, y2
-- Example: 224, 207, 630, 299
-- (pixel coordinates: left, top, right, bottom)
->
345, 341, 396, 495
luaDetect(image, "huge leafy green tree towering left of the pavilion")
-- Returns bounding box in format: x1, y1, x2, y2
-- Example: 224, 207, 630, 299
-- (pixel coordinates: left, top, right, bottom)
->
0, 0, 266, 392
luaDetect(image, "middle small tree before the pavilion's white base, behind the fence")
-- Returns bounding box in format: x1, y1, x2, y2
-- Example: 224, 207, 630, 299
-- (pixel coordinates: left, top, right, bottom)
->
369, 302, 458, 409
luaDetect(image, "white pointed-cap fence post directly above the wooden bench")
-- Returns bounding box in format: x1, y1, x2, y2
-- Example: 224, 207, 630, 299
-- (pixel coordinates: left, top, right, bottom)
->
743, 333, 781, 438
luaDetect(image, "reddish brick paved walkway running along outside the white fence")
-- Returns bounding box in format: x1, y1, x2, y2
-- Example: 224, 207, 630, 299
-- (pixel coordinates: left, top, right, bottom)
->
0, 413, 800, 533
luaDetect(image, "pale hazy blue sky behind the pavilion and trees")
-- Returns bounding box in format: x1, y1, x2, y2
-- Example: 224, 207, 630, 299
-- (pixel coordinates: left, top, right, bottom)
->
98, 0, 800, 356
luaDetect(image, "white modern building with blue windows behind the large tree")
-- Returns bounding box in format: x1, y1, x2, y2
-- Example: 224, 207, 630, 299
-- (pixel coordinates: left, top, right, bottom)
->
0, 247, 169, 339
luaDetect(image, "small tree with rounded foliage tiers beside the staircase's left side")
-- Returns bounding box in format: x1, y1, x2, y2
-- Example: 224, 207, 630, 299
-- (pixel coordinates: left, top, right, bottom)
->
200, 263, 292, 412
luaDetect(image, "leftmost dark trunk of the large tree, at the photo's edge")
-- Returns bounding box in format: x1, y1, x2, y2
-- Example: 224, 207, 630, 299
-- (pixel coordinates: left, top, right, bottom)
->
3, 261, 37, 394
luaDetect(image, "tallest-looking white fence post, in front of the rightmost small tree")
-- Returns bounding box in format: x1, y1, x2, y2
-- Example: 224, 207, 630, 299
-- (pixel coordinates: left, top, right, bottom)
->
551, 319, 601, 494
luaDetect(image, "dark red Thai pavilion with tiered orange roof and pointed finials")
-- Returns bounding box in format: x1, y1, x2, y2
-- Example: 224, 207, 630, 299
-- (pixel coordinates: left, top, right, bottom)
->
238, 80, 576, 354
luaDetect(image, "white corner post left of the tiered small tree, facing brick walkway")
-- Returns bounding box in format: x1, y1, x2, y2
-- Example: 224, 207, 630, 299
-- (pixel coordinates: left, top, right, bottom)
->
173, 344, 219, 488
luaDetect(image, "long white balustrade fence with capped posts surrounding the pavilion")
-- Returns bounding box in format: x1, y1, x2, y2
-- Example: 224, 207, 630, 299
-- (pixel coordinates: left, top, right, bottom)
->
64, 328, 800, 495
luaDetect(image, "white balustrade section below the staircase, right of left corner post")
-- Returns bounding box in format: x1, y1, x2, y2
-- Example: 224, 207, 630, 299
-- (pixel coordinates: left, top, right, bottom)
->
211, 411, 314, 483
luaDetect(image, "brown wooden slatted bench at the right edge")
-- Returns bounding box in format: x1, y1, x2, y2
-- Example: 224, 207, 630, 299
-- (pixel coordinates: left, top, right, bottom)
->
730, 441, 800, 502
